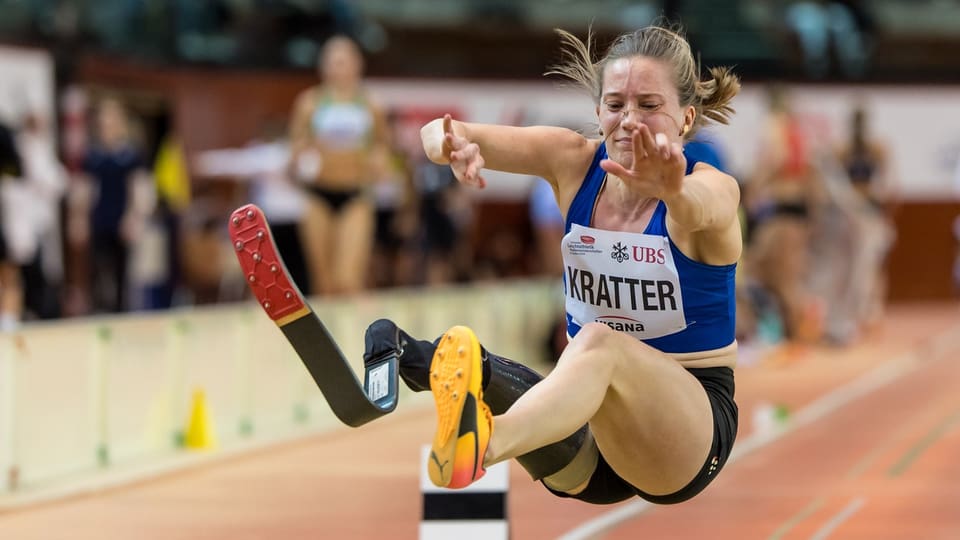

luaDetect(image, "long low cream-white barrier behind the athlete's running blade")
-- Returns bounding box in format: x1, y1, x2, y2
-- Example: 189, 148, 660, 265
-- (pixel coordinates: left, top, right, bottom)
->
0, 281, 561, 496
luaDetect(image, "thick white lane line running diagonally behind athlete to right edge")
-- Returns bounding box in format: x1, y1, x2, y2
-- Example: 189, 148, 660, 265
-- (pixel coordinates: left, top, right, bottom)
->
559, 328, 960, 540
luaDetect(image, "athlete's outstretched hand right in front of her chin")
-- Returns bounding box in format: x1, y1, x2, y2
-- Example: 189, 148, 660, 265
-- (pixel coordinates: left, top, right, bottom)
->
600, 124, 687, 199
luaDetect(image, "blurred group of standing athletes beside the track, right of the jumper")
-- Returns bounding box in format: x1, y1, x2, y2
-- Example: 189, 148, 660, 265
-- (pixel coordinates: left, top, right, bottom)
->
738, 85, 896, 358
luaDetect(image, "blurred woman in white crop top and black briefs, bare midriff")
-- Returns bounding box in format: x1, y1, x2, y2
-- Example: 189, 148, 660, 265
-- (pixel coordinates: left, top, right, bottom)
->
290, 36, 388, 295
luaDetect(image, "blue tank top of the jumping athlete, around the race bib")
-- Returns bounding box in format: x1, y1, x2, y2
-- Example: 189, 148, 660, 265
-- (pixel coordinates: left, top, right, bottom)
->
564, 144, 737, 353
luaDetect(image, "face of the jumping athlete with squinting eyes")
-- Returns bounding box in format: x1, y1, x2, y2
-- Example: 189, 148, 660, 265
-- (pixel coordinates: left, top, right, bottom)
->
597, 56, 695, 166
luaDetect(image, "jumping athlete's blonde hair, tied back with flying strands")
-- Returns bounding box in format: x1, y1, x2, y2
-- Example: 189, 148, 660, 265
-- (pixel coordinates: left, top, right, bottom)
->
546, 25, 740, 138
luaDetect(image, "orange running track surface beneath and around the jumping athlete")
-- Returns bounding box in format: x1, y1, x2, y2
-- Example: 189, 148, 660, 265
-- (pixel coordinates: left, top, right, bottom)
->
0, 304, 960, 540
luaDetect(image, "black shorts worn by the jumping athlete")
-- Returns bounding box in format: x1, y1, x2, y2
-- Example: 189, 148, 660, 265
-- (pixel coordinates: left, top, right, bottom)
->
547, 367, 738, 504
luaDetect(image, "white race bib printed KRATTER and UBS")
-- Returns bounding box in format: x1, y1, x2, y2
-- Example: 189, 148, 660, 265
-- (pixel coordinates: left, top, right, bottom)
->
562, 224, 687, 339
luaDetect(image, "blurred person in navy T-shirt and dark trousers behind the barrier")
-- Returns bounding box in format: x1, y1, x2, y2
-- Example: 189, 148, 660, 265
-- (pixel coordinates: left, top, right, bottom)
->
78, 98, 154, 312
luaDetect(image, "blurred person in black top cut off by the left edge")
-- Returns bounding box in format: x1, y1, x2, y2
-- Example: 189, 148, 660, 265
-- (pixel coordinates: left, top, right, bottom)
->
0, 117, 23, 332
